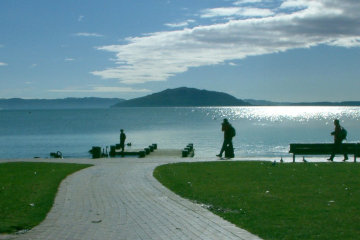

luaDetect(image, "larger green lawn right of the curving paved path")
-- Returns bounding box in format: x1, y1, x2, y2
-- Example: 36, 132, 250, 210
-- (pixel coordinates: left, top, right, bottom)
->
154, 162, 360, 240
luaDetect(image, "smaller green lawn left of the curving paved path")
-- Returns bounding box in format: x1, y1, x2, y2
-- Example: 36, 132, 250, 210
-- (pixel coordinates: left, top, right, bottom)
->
0, 162, 91, 233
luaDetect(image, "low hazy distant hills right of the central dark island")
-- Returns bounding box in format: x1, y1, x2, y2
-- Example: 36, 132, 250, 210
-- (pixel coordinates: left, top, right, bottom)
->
244, 99, 360, 106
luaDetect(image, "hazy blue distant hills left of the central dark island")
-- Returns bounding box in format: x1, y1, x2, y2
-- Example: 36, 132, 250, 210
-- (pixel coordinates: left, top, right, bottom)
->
0, 97, 124, 109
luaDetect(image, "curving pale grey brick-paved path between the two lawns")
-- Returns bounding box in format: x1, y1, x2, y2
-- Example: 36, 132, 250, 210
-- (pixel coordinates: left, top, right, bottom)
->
3, 157, 259, 240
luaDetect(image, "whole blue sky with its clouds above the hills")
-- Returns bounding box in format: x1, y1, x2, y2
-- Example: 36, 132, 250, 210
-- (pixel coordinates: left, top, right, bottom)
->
0, 0, 360, 102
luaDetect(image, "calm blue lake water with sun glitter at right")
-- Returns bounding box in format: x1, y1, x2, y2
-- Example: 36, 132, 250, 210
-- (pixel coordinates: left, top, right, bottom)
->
0, 107, 360, 158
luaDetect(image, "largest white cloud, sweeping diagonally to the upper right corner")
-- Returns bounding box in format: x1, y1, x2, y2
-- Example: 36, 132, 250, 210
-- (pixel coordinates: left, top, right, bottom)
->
92, 0, 360, 84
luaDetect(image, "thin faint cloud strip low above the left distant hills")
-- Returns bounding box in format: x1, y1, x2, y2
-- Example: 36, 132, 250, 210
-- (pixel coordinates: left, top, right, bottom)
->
49, 87, 151, 93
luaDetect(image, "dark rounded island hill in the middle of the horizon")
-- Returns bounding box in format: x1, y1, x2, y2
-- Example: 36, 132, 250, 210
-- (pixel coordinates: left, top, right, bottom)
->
114, 87, 250, 107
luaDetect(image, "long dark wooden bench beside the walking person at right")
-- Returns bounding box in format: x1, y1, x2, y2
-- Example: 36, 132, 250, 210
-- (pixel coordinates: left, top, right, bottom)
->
289, 143, 360, 162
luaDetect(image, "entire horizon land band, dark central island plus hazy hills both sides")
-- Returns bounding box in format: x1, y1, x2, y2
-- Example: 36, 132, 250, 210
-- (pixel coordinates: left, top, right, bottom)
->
0, 87, 360, 109
